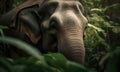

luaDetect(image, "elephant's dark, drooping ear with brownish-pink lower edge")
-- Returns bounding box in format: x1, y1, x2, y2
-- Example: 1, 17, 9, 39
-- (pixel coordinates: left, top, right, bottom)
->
14, 5, 41, 44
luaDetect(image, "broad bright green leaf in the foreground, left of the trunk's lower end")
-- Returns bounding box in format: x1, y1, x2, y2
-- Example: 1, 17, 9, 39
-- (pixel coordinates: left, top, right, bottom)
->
44, 53, 67, 71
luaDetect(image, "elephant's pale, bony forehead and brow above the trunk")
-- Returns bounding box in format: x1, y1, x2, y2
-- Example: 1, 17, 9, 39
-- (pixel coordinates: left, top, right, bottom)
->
42, 0, 86, 27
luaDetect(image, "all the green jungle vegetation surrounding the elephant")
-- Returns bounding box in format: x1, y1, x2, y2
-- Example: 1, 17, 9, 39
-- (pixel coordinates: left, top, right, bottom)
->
0, 0, 120, 72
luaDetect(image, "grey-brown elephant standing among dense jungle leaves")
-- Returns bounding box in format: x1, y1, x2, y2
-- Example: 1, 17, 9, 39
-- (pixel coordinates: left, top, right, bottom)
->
0, 0, 88, 64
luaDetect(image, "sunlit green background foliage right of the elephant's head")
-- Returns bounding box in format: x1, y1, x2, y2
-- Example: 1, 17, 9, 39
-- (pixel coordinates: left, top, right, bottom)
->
84, 0, 120, 72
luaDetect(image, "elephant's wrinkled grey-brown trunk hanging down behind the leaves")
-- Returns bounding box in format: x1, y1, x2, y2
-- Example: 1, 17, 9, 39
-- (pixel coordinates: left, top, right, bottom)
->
58, 27, 85, 64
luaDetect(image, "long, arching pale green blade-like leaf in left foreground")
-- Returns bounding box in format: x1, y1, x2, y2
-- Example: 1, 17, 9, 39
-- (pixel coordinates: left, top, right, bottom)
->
0, 37, 46, 64
